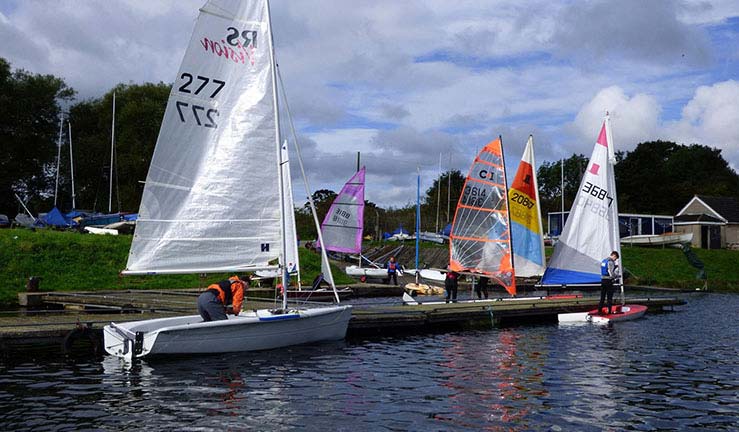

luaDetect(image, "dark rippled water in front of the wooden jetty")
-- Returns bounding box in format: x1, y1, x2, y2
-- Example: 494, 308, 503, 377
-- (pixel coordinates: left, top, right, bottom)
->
0, 294, 739, 432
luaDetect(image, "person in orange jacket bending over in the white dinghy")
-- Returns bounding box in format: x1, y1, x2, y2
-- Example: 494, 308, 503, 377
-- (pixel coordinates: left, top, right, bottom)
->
198, 276, 251, 321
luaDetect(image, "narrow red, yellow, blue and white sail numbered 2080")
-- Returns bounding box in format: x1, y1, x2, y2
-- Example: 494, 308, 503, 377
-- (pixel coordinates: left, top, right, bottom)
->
508, 135, 546, 277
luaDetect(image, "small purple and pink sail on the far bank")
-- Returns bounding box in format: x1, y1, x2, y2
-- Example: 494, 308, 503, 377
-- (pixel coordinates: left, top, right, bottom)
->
321, 167, 365, 253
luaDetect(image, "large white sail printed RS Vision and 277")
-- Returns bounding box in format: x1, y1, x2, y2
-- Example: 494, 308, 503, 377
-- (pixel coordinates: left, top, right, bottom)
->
124, 0, 280, 274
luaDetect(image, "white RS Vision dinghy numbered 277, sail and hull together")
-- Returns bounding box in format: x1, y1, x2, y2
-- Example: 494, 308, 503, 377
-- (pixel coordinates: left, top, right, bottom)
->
104, 0, 351, 360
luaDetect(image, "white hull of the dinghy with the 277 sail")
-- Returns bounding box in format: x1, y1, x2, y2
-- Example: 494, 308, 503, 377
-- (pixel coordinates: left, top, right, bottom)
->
103, 306, 352, 360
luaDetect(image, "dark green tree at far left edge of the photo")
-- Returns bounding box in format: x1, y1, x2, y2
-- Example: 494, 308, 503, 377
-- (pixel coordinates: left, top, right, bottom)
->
0, 58, 74, 217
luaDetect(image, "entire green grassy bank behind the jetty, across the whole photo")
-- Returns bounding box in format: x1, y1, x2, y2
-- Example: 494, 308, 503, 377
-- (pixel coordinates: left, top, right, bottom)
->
0, 229, 739, 307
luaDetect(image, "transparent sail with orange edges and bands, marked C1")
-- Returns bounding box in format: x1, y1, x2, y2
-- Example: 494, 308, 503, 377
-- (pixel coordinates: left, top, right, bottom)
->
449, 137, 516, 295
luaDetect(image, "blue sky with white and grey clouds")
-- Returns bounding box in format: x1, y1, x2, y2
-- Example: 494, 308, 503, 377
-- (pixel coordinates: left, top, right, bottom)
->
0, 0, 739, 207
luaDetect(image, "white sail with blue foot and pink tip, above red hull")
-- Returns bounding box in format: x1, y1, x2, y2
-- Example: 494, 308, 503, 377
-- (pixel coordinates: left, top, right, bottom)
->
541, 117, 621, 285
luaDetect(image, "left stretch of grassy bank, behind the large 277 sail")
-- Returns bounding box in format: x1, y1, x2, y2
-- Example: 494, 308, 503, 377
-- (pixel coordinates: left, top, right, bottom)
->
0, 229, 353, 307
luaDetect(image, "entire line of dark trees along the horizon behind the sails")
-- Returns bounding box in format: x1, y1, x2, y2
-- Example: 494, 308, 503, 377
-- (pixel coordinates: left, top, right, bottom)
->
5, 58, 739, 239
